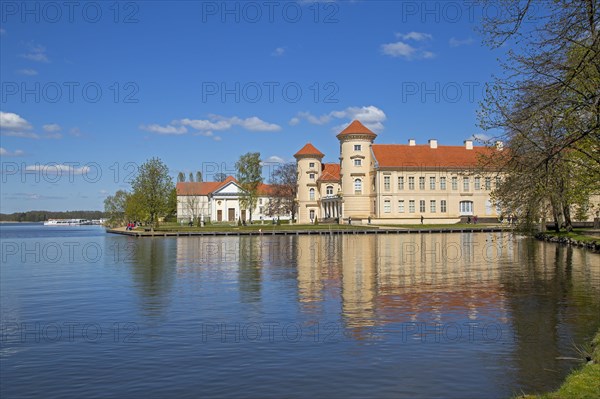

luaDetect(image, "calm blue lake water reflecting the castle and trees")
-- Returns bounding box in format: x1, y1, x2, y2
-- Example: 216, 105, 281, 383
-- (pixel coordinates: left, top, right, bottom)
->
0, 225, 600, 399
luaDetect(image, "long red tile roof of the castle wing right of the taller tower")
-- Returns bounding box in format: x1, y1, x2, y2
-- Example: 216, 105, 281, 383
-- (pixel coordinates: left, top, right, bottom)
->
373, 144, 493, 168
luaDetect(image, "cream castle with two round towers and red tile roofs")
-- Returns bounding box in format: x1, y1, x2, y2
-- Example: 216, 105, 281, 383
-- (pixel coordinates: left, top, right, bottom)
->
294, 120, 501, 224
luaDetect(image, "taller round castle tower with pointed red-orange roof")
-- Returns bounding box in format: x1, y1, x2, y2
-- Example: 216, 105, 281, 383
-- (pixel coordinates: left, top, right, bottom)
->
336, 120, 377, 221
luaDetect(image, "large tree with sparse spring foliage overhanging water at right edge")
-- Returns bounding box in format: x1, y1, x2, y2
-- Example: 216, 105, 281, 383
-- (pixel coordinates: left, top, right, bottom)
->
480, 0, 600, 230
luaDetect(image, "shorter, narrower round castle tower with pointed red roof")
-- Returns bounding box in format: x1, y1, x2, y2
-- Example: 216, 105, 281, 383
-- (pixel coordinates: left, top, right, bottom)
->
294, 143, 324, 223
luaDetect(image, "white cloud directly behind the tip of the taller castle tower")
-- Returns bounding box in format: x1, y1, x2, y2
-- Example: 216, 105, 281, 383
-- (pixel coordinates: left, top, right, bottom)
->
290, 105, 387, 132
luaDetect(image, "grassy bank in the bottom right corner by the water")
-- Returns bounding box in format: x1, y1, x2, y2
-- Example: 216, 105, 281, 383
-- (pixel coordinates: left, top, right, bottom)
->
518, 329, 600, 399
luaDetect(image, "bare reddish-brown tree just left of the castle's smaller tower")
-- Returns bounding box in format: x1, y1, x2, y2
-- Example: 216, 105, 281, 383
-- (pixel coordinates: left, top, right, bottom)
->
266, 163, 298, 219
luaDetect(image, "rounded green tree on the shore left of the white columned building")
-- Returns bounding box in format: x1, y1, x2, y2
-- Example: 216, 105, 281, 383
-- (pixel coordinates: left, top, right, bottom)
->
131, 158, 174, 228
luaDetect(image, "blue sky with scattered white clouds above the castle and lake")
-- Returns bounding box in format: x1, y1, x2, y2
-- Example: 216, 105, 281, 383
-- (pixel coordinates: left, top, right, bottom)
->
0, 1, 516, 213
